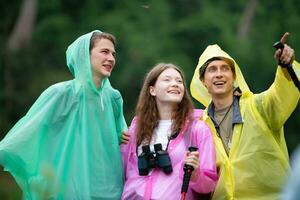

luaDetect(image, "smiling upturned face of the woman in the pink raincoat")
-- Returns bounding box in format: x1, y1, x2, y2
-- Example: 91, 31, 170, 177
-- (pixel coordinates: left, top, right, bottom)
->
150, 68, 184, 104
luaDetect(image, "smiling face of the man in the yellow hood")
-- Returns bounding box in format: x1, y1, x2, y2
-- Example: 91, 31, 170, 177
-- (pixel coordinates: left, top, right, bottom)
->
202, 60, 235, 98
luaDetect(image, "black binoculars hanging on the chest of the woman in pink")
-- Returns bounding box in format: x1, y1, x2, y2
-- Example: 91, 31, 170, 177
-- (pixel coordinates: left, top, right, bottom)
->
138, 143, 173, 176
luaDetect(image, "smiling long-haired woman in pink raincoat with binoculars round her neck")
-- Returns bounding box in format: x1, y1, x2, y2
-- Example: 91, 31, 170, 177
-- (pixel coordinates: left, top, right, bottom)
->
121, 63, 217, 200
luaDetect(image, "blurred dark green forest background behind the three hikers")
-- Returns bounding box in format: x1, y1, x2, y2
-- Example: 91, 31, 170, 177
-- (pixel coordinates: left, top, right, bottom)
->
0, 0, 300, 199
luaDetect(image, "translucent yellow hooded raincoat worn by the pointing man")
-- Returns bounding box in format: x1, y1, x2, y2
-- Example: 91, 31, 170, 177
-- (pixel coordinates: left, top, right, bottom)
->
190, 45, 300, 200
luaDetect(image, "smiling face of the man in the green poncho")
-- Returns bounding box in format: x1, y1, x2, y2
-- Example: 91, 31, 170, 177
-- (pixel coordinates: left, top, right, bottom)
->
90, 38, 116, 80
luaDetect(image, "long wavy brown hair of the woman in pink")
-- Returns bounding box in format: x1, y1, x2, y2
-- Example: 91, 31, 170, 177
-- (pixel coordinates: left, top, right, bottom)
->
136, 63, 193, 146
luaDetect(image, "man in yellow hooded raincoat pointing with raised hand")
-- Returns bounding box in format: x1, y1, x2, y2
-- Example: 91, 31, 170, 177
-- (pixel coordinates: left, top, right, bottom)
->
191, 33, 300, 200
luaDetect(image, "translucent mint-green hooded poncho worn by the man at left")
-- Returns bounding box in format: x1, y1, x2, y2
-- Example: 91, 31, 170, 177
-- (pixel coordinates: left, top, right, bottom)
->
0, 31, 127, 200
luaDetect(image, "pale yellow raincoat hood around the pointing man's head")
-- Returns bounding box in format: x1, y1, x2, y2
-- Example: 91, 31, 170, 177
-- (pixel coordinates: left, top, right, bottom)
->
190, 44, 250, 107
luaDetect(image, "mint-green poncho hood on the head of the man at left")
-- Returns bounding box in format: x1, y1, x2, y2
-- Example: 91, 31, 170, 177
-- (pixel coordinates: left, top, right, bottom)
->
66, 30, 111, 93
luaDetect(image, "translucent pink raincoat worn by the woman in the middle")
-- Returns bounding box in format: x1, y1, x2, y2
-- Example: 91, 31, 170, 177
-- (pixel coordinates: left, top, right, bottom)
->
121, 111, 217, 200
